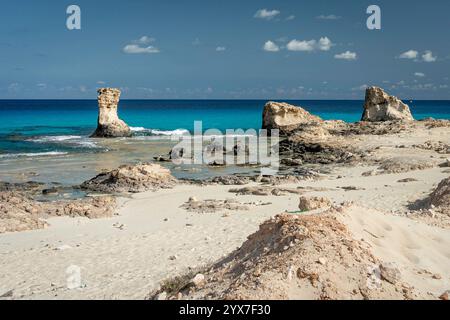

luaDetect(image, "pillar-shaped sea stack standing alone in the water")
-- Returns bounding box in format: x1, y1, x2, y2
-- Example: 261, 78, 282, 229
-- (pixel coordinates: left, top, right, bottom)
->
91, 88, 131, 138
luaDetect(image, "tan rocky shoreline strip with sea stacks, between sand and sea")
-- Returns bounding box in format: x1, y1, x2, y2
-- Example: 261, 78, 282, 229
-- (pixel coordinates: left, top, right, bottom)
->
0, 87, 450, 233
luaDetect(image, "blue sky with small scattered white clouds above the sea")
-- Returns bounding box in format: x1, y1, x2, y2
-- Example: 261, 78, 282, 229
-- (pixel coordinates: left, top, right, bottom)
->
0, 0, 450, 99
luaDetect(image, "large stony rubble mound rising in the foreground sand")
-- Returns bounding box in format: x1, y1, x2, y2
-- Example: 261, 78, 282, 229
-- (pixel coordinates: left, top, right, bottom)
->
150, 208, 406, 300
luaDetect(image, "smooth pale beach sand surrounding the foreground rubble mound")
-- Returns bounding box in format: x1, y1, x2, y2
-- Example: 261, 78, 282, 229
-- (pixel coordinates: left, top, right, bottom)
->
0, 120, 450, 299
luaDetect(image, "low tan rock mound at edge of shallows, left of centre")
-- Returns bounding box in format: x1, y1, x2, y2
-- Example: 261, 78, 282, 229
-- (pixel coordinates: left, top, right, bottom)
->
81, 163, 176, 192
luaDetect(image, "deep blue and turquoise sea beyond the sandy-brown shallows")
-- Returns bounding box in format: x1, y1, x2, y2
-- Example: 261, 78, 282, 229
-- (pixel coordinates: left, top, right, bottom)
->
0, 100, 450, 156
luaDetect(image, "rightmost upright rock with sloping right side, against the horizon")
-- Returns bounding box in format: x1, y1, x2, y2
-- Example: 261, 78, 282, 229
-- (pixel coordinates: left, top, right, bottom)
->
361, 87, 414, 122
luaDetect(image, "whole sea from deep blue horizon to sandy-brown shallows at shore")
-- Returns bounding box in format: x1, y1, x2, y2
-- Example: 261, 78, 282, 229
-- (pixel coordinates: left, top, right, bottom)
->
0, 100, 450, 185
